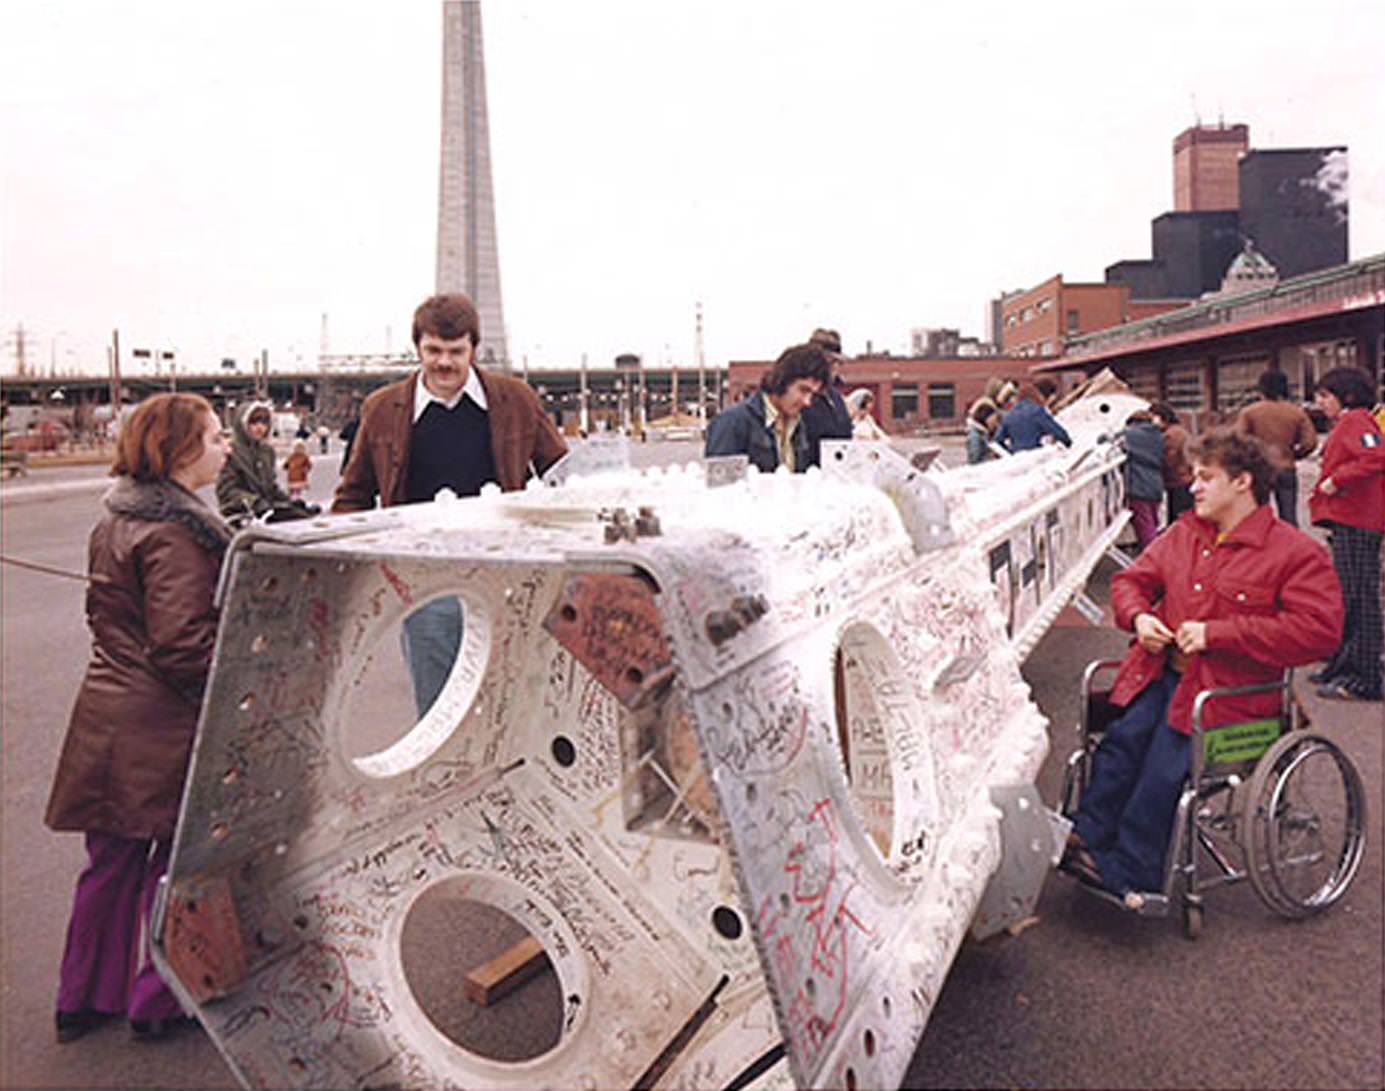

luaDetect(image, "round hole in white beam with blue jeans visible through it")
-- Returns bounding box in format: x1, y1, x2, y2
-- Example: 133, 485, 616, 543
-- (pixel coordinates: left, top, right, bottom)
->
338, 594, 490, 777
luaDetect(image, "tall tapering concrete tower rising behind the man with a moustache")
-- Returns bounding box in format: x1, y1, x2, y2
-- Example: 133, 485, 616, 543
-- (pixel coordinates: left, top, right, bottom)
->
436, 0, 510, 367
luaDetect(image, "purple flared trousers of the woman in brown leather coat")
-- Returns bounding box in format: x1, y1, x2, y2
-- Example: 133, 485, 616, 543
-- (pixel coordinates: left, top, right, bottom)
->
58, 832, 183, 1019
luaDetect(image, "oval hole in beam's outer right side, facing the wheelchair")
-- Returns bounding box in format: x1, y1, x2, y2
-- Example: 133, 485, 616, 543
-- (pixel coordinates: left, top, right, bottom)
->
832, 622, 938, 858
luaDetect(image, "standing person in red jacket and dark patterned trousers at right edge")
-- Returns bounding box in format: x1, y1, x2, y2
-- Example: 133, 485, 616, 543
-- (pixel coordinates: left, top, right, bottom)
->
1307, 367, 1385, 701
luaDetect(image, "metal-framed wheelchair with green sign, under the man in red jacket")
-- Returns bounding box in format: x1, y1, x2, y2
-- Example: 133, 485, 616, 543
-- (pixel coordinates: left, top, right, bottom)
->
1060, 659, 1366, 940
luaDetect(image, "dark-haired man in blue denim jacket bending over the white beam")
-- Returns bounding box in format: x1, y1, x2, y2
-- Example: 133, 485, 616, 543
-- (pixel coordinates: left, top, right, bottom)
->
702, 345, 832, 474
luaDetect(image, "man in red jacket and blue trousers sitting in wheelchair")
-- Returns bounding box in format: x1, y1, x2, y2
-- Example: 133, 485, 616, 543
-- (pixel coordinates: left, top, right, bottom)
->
1062, 429, 1343, 897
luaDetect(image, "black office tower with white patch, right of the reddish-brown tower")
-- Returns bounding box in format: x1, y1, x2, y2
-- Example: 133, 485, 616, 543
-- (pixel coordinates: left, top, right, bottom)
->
1241, 147, 1348, 277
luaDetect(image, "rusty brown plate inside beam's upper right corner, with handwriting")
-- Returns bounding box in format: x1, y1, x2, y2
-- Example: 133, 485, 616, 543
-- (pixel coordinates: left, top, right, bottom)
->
543, 573, 672, 709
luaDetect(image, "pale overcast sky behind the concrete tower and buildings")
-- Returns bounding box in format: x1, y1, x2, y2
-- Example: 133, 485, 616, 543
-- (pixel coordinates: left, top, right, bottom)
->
0, 0, 1385, 372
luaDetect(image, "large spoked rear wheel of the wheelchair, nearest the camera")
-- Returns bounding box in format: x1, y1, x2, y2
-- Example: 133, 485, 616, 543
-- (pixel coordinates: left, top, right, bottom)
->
1241, 731, 1366, 917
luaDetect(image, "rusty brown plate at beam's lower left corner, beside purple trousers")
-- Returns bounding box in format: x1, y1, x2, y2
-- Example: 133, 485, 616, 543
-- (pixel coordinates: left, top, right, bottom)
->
163, 876, 245, 1004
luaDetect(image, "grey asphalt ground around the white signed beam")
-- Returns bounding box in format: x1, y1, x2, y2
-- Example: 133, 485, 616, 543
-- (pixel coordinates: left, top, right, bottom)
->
0, 444, 1385, 1088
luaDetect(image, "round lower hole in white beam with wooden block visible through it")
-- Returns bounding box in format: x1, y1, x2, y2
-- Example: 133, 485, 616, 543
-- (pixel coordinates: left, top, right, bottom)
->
399, 875, 590, 1063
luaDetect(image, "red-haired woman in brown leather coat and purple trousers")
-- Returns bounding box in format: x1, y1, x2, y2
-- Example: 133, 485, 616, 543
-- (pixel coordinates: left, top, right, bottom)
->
46, 395, 230, 1041
